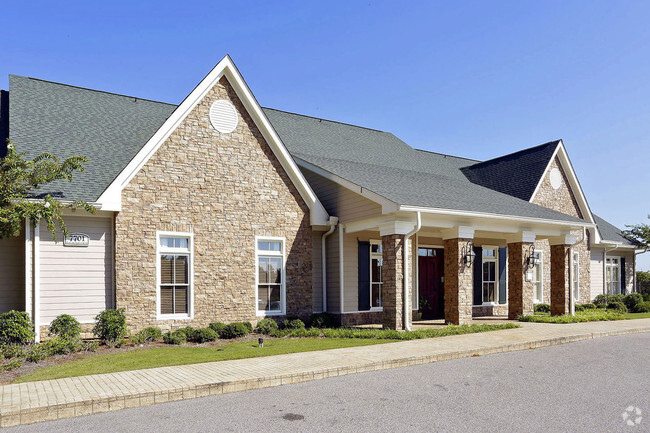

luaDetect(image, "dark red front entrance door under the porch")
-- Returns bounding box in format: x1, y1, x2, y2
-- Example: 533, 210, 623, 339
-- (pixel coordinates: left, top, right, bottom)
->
418, 247, 445, 319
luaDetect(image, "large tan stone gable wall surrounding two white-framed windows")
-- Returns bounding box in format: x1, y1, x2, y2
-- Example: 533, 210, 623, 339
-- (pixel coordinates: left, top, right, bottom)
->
115, 77, 312, 329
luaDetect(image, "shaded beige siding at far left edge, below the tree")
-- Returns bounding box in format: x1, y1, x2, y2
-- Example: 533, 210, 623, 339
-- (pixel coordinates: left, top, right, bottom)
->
0, 230, 25, 312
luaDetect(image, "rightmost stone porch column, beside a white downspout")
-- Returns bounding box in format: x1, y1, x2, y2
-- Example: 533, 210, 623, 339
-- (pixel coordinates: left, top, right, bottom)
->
549, 236, 576, 316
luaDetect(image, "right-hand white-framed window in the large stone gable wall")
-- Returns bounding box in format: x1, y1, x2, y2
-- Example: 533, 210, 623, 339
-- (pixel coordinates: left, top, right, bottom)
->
255, 237, 286, 316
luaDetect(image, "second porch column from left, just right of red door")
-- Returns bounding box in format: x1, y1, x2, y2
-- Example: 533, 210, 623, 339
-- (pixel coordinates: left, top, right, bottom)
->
444, 238, 470, 325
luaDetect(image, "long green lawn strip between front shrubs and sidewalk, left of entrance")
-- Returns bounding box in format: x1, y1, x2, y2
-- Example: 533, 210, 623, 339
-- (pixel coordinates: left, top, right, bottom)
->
14, 323, 519, 383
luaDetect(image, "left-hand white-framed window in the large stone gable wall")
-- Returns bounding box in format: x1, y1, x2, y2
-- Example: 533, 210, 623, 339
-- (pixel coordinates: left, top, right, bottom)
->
156, 232, 194, 319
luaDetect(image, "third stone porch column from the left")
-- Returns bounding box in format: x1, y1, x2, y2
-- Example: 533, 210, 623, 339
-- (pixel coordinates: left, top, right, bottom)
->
508, 239, 535, 320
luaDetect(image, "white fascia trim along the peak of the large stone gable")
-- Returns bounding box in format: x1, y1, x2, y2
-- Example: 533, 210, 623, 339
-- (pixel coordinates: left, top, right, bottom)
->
97, 56, 329, 225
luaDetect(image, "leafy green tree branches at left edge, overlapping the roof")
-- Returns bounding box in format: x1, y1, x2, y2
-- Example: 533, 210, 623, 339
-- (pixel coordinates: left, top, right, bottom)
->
0, 140, 95, 240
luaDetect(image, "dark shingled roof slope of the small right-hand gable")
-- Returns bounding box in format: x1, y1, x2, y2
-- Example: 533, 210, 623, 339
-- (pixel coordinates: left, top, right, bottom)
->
461, 140, 560, 200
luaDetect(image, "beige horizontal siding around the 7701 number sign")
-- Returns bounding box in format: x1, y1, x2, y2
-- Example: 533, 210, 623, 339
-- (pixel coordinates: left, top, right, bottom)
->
40, 217, 113, 325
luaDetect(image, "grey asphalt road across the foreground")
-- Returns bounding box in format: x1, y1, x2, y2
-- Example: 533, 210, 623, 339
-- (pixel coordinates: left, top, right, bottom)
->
6, 325, 650, 433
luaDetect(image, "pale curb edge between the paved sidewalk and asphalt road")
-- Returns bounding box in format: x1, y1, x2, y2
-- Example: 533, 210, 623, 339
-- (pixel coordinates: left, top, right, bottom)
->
0, 325, 650, 427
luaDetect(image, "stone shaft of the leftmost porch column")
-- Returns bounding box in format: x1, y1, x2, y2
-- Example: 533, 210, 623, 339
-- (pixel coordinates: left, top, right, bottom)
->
381, 234, 404, 329
